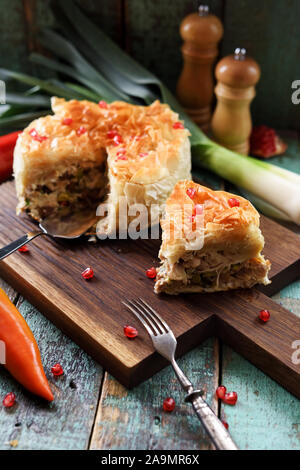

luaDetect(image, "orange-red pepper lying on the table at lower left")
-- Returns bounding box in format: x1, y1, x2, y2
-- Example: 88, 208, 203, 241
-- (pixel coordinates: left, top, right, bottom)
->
0, 289, 53, 401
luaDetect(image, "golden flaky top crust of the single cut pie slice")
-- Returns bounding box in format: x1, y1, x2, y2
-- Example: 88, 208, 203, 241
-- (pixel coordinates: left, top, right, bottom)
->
160, 180, 263, 262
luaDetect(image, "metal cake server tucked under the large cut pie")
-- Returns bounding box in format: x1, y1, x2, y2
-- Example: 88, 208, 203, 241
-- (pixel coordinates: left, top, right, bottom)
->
0, 212, 97, 260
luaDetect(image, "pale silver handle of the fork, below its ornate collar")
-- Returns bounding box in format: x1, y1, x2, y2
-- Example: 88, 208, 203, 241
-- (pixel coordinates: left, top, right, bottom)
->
185, 391, 238, 450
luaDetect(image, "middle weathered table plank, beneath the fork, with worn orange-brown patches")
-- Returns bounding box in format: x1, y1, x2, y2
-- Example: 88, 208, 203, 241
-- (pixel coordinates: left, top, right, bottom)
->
91, 339, 219, 450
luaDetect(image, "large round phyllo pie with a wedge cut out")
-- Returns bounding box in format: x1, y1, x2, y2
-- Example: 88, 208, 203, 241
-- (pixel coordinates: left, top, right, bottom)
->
14, 98, 191, 232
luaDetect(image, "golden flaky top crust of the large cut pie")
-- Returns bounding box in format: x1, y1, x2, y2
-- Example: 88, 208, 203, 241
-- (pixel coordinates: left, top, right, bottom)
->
15, 98, 189, 184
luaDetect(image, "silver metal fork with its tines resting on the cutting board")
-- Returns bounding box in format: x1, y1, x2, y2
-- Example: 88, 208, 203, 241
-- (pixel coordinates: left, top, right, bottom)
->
122, 299, 238, 450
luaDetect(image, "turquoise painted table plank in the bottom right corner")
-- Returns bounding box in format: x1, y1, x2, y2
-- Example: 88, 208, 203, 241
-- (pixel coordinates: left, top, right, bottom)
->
221, 290, 300, 450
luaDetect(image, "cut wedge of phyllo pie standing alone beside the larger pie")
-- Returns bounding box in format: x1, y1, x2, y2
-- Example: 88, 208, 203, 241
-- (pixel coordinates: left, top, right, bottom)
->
155, 180, 271, 294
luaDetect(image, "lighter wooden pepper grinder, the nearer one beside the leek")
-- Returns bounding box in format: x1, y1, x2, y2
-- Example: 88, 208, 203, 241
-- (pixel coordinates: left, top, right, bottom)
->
211, 48, 260, 155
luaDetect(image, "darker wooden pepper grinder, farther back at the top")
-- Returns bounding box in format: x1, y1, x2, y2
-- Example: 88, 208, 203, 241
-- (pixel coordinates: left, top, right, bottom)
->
177, 5, 223, 131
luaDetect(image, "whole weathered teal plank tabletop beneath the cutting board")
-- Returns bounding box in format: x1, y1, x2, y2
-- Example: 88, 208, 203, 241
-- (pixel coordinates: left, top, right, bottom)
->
0, 138, 300, 450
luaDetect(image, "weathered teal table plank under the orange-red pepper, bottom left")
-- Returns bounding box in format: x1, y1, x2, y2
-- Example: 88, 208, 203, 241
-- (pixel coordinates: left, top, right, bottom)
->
0, 281, 103, 450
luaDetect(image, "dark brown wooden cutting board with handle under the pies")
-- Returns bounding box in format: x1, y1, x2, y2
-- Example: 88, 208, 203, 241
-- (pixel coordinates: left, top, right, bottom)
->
0, 182, 300, 397
